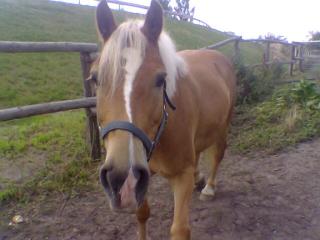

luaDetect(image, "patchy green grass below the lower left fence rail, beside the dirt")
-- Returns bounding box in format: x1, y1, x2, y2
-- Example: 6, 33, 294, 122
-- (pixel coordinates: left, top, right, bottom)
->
0, 111, 96, 203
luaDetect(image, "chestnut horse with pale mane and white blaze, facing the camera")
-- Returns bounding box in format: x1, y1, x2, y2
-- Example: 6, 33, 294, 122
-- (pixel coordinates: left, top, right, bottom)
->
96, 0, 236, 240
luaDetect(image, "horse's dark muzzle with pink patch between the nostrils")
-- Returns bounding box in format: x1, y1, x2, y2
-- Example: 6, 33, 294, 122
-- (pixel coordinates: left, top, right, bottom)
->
100, 165, 150, 210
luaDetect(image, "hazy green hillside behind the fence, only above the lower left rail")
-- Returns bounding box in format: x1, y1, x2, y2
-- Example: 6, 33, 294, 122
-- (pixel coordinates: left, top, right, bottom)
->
0, 0, 257, 108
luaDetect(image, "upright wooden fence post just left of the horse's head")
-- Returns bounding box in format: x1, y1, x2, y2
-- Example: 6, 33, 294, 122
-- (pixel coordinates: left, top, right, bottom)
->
80, 52, 101, 160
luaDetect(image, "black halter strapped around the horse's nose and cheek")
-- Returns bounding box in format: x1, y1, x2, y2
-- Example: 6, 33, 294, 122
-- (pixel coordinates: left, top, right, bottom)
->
100, 81, 176, 161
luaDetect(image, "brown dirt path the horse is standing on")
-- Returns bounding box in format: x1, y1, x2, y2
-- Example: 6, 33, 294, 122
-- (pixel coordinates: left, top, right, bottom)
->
0, 139, 320, 240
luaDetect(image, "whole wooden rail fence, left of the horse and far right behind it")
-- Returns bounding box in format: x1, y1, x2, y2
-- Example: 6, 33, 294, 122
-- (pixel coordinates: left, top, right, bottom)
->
0, 37, 316, 159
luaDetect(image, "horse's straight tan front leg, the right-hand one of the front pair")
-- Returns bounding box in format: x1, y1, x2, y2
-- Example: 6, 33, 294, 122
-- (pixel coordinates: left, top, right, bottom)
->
170, 167, 194, 240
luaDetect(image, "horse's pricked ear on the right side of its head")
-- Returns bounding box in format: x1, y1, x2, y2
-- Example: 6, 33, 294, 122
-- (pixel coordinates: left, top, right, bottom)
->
142, 0, 163, 43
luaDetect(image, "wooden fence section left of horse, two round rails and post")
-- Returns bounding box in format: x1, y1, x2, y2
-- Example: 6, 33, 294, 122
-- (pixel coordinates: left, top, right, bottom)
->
0, 41, 101, 159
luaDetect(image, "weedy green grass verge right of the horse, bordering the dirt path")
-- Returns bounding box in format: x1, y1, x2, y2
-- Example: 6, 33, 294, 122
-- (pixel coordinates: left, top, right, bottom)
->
230, 82, 320, 153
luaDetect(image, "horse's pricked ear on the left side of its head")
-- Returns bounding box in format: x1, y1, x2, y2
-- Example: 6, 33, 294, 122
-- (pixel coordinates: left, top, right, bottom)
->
96, 0, 117, 41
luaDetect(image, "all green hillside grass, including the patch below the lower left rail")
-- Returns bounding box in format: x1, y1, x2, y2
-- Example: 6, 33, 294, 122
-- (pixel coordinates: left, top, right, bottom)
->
0, 0, 260, 202
